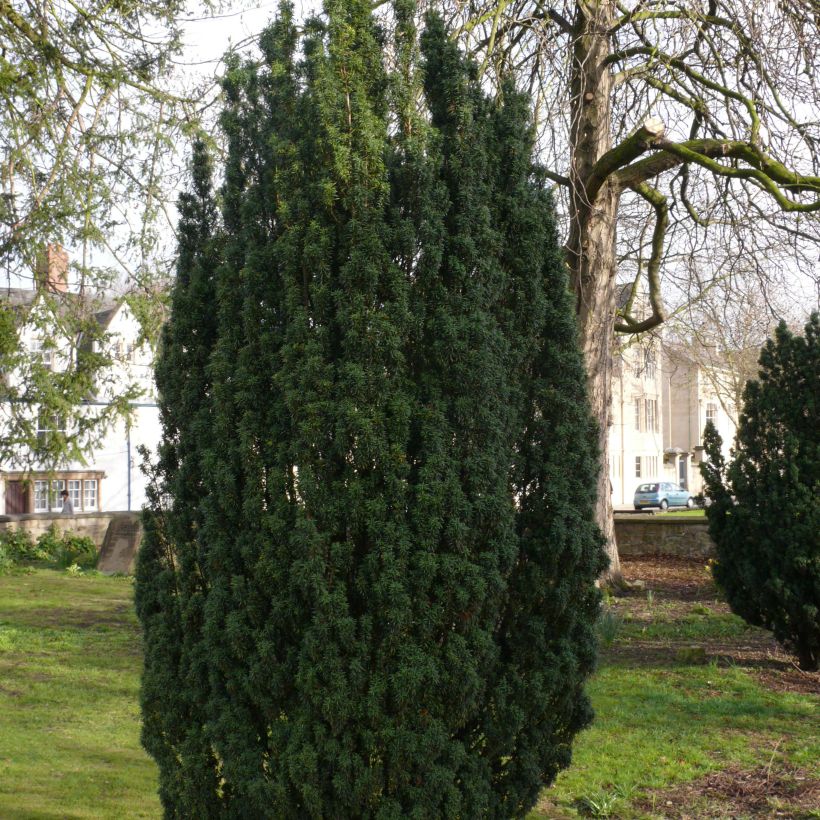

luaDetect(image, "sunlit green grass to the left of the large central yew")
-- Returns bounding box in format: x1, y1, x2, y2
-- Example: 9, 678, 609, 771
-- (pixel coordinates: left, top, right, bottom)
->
0, 570, 161, 820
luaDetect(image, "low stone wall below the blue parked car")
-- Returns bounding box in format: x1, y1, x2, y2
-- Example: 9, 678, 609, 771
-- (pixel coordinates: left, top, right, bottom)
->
615, 513, 715, 559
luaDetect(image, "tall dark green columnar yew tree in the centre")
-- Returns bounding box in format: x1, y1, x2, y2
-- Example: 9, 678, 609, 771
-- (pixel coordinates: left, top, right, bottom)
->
137, 0, 604, 818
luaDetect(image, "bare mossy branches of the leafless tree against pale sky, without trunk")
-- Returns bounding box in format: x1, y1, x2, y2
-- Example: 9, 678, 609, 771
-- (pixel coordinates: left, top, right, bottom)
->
429, 0, 820, 331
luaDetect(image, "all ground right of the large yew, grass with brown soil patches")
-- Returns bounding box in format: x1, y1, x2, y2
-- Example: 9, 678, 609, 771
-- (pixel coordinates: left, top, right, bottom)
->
530, 559, 820, 820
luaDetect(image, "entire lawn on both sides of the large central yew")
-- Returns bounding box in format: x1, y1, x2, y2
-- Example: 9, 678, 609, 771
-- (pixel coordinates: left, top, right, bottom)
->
0, 561, 820, 820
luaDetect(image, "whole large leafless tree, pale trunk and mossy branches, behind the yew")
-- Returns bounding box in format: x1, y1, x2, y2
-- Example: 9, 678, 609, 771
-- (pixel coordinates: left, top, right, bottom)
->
410, 0, 820, 577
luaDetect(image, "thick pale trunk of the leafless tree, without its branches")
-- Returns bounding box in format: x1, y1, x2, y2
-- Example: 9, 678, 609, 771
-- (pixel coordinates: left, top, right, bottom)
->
567, 0, 621, 583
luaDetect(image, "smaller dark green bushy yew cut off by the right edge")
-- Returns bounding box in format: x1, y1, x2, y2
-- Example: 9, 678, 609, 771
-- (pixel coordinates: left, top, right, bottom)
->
701, 313, 820, 669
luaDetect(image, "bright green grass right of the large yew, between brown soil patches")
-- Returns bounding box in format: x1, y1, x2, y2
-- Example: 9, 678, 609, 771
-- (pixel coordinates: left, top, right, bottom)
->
530, 665, 820, 820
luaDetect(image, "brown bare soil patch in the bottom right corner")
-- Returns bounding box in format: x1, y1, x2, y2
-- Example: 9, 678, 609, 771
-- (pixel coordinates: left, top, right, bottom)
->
637, 766, 820, 820
